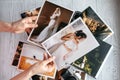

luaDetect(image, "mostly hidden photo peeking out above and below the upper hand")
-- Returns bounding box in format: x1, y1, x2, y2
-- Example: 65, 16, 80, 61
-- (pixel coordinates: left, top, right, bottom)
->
21, 7, 40, 36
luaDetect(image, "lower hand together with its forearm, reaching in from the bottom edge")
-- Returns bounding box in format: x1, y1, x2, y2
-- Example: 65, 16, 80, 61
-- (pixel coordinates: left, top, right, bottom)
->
10, 54, 55, 80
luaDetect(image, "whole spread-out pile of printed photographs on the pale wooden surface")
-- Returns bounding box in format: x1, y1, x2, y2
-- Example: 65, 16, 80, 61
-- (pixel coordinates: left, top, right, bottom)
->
12, 1, 113, 80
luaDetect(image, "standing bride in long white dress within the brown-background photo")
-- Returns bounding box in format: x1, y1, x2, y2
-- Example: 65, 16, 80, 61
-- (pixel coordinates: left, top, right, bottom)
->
35, 8, 61, 42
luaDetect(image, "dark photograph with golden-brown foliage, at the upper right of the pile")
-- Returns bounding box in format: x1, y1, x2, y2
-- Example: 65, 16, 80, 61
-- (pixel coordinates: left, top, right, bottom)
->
72, 7, 113, 40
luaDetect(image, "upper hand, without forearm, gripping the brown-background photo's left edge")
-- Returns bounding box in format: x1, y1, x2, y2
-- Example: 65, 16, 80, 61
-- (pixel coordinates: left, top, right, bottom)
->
9, 16, 38, 33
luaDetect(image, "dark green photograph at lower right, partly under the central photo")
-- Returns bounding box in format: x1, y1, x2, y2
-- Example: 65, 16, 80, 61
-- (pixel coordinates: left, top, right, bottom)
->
73, 40, 112, 78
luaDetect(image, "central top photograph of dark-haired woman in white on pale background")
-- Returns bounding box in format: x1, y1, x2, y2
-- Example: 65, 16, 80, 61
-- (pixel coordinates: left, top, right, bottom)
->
42, 18, 99, 70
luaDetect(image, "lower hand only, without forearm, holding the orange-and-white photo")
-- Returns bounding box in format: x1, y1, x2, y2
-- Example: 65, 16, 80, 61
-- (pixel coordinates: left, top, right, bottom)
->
30, 54, 55, 75
